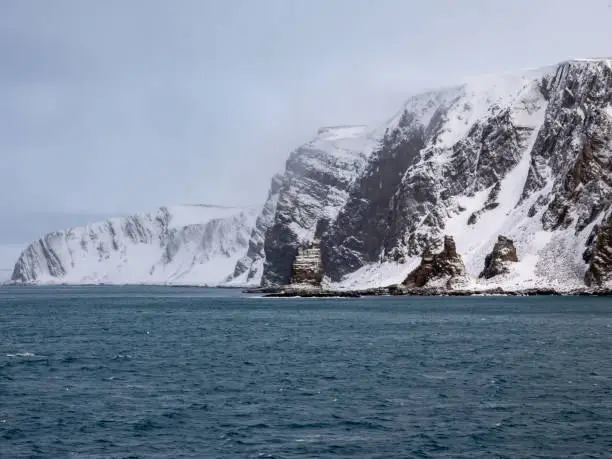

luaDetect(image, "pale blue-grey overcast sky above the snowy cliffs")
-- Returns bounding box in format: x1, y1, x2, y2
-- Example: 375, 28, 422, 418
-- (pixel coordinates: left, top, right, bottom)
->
0, 0, 612, 214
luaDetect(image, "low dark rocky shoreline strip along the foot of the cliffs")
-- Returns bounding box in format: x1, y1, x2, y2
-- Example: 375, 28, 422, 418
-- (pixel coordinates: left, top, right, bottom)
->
243, 286, 612, 298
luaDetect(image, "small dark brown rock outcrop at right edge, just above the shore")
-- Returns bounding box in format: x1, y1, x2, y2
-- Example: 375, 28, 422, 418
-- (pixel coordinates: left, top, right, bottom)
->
584, 215, 612, 287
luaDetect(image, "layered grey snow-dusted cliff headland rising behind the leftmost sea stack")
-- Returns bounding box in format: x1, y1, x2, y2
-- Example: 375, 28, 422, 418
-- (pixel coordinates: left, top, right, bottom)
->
262, 126, 373, 286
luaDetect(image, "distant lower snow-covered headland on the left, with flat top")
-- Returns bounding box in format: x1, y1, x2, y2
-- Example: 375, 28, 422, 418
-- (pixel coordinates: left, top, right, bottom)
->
12, 205, 260, 285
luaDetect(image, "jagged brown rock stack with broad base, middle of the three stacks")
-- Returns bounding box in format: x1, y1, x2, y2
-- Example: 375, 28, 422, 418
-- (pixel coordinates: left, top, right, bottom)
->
403, 236, 466, 288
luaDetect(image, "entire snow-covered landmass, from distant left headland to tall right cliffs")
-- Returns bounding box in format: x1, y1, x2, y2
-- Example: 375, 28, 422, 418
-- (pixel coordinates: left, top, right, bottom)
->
8, 59, 612, 291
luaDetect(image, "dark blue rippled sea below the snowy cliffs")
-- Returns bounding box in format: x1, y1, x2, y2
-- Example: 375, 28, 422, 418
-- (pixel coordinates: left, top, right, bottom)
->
0, 287, 612, 458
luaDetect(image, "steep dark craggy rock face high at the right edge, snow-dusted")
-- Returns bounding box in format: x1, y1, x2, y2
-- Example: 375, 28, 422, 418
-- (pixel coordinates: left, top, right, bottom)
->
522, 61, 612, 233
